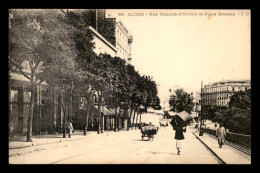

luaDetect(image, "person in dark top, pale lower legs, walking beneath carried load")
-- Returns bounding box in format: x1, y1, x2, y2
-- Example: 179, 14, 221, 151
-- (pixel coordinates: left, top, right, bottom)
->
173, 120, 186, 155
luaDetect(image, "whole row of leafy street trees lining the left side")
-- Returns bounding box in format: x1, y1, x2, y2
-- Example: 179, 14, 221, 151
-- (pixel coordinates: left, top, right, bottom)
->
9, 10, 159, 141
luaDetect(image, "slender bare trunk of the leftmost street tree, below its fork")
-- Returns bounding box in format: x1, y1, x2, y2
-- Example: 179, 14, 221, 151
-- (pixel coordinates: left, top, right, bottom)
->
26, 84, 35, 142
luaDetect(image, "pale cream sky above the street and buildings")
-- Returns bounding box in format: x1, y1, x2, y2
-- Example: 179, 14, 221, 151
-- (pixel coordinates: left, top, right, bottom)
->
105, 9, 251, 91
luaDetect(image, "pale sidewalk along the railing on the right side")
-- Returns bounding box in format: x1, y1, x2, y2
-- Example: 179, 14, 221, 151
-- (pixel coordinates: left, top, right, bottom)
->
193, 132, 251, 164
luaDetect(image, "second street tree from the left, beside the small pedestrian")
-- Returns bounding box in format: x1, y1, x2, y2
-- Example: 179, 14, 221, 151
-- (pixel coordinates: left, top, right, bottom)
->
35, 10, 80, 138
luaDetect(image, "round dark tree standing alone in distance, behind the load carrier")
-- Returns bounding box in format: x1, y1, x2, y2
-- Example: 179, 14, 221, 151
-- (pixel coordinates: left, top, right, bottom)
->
169, 89, 194, 114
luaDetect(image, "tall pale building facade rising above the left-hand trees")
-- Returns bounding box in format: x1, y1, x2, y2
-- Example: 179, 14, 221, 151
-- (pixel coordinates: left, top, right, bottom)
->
115, 21, 133, 64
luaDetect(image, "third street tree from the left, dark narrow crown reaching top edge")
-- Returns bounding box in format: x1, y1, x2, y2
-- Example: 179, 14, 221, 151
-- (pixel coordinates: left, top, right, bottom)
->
66, 11, 97, 135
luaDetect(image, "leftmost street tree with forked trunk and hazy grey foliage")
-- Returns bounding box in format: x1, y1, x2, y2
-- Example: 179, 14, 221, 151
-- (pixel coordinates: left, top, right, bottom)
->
9, 10, 72, 142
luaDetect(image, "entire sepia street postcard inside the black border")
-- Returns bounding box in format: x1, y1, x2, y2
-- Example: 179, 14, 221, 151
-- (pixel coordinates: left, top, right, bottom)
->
8, 9, 251, 165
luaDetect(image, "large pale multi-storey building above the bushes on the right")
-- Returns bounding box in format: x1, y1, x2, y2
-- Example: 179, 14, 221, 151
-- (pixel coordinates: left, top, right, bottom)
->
202, 80, 251, 106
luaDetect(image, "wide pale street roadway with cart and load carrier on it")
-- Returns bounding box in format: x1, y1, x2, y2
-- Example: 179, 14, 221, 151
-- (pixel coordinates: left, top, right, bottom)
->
9, 126, 218, 164
